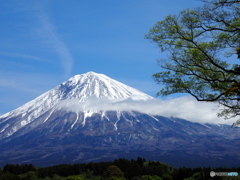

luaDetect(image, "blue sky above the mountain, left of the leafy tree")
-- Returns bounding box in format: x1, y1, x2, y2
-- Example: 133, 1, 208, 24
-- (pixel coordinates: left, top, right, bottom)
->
0, 0, 214, 115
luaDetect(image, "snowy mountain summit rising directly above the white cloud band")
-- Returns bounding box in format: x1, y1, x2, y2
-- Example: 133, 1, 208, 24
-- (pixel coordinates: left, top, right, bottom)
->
57, 72, 152, 102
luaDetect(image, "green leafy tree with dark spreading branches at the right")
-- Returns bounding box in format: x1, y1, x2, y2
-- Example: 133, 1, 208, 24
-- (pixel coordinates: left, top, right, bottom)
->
146, 0, 240, 125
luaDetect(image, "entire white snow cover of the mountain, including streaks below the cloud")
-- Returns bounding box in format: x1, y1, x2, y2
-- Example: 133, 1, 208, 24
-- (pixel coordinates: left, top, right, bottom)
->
0, 72, 154, 139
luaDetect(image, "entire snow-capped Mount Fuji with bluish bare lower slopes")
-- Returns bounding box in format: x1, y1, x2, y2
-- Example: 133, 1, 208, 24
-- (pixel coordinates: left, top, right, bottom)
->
0, 72, 240, 167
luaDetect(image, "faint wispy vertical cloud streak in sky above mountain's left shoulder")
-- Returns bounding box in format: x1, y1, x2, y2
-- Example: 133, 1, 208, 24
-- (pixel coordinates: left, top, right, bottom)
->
36, 4, 74, 77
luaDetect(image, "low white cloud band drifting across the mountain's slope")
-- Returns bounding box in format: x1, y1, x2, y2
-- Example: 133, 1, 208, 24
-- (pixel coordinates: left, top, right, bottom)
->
58, 96, 236, 125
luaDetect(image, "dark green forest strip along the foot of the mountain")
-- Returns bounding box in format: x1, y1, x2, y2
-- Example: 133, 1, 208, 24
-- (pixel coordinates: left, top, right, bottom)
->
0, 157, 240, 180
